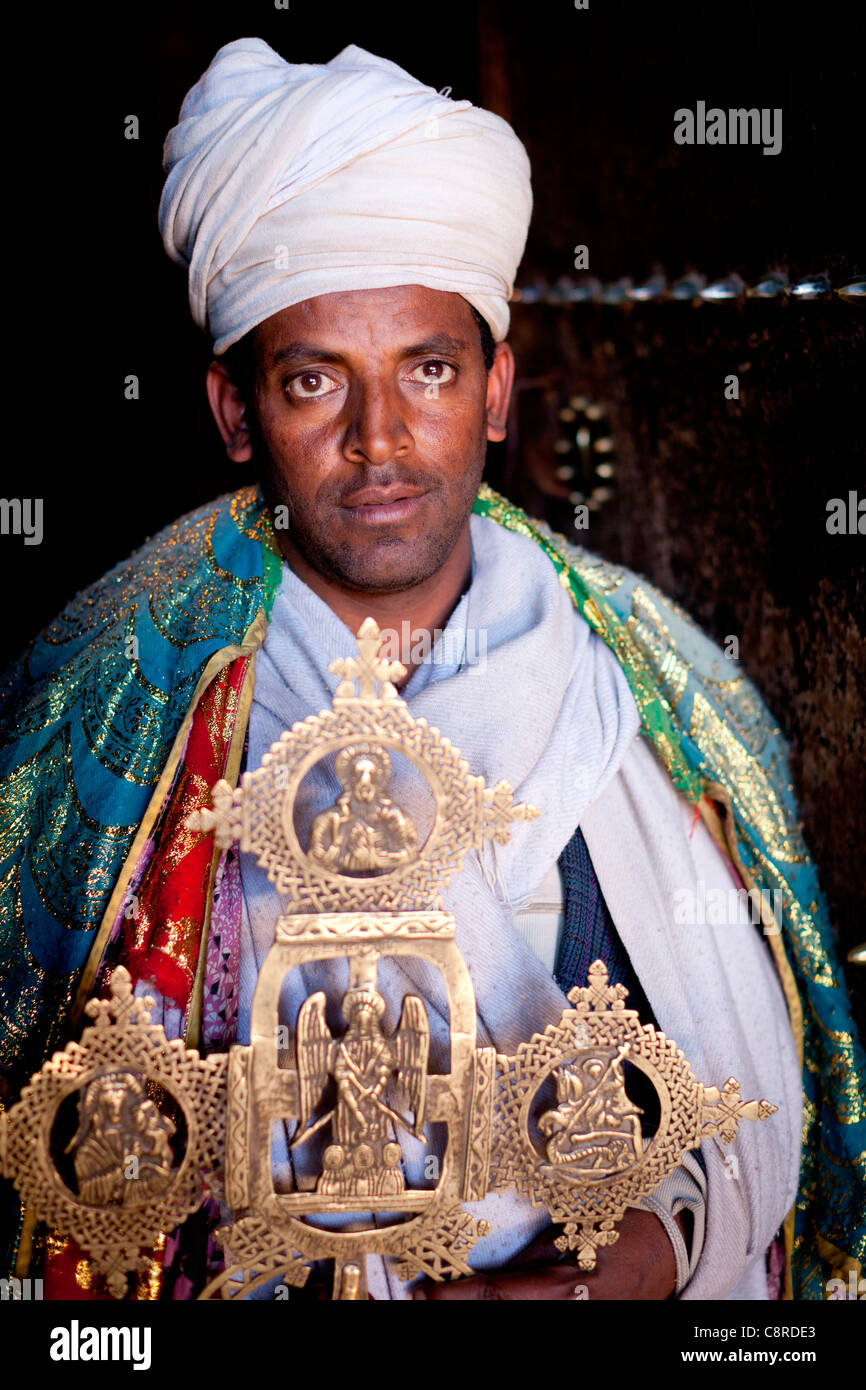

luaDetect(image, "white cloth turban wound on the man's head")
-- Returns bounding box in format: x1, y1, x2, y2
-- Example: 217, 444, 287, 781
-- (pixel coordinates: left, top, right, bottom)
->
160, 39, 532, 353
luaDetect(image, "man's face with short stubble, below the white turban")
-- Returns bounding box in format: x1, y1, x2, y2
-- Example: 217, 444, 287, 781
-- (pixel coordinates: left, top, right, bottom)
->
239, 285, 507, 594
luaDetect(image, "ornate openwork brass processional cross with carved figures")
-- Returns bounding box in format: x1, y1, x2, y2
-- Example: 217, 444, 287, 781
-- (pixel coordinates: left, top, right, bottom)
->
0, 619, 776, 1300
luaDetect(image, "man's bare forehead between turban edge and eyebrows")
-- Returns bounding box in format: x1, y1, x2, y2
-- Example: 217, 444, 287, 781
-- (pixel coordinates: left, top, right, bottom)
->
254, 285, 478, 354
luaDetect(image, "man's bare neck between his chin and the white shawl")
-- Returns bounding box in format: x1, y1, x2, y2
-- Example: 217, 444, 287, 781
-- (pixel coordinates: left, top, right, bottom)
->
279, 521, 473, 689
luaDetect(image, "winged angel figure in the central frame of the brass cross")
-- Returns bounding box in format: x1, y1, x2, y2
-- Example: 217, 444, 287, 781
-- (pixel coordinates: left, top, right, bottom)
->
292, 984, 430, 1197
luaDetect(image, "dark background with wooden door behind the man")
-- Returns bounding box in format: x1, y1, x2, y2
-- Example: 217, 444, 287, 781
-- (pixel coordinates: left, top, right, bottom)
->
0, 0, 866, 1016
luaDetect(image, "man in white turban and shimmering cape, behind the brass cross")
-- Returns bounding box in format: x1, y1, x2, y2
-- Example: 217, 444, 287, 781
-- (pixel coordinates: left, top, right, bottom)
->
0, 39, 863, 1298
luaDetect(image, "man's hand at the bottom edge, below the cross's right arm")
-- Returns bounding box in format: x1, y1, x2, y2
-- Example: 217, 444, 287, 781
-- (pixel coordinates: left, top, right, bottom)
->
413, 1207, 681, 1302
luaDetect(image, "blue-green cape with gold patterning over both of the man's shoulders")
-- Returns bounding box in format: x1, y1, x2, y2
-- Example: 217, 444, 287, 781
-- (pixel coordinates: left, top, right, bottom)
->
0, 487, 866, 1298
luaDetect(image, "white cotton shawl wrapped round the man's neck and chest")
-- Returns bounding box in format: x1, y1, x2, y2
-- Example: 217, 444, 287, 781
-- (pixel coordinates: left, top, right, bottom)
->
239, 517, 799, 1298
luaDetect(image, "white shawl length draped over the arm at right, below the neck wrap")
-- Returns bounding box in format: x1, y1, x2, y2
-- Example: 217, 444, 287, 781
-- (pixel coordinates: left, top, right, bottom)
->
581, 741, 802, 1300
